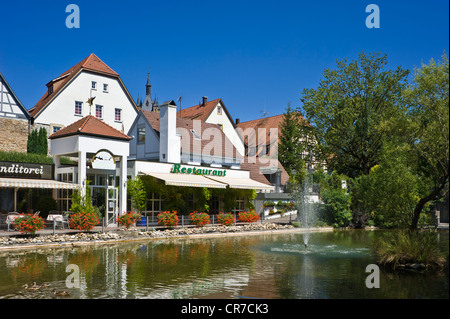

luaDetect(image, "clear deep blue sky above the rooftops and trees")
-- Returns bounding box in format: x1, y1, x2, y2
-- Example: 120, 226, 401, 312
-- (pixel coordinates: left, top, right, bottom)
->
0, 0, 449, 121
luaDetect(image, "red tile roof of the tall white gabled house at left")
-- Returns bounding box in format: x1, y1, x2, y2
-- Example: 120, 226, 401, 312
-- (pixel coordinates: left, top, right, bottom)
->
29, 53, 134, 117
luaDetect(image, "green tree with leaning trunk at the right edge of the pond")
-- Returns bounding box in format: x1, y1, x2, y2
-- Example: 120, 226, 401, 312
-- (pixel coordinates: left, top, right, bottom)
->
405, 55, 449, 229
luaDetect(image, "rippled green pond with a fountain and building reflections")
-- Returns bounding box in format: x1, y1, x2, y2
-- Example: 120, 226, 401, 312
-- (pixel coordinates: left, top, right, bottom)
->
0, 231, 449, 299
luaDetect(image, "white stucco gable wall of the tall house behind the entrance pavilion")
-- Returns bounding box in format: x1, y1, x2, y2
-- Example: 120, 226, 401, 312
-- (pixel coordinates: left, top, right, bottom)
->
35, 71, 137, 133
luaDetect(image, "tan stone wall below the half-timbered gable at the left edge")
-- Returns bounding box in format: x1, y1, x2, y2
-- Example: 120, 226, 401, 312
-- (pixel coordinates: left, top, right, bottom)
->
0, 117, 28, 152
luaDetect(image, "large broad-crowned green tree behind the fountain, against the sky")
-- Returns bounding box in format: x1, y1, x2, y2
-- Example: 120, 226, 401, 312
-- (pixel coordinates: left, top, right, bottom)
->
299, 52, 409, 177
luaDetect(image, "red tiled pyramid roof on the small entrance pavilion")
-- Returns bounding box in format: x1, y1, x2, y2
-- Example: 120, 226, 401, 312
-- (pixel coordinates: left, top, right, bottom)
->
49, 115, 131, 140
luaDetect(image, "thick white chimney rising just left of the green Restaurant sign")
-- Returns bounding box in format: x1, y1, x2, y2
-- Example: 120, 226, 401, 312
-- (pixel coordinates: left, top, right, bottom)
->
159, 100, 181, 163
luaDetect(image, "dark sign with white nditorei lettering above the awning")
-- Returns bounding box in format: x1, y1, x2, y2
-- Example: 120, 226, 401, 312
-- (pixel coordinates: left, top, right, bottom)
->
0, 162, 53, 179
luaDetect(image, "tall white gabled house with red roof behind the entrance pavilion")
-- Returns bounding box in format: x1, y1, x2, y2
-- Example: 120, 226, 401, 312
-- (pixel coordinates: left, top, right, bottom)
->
29, 54, 138, 134
